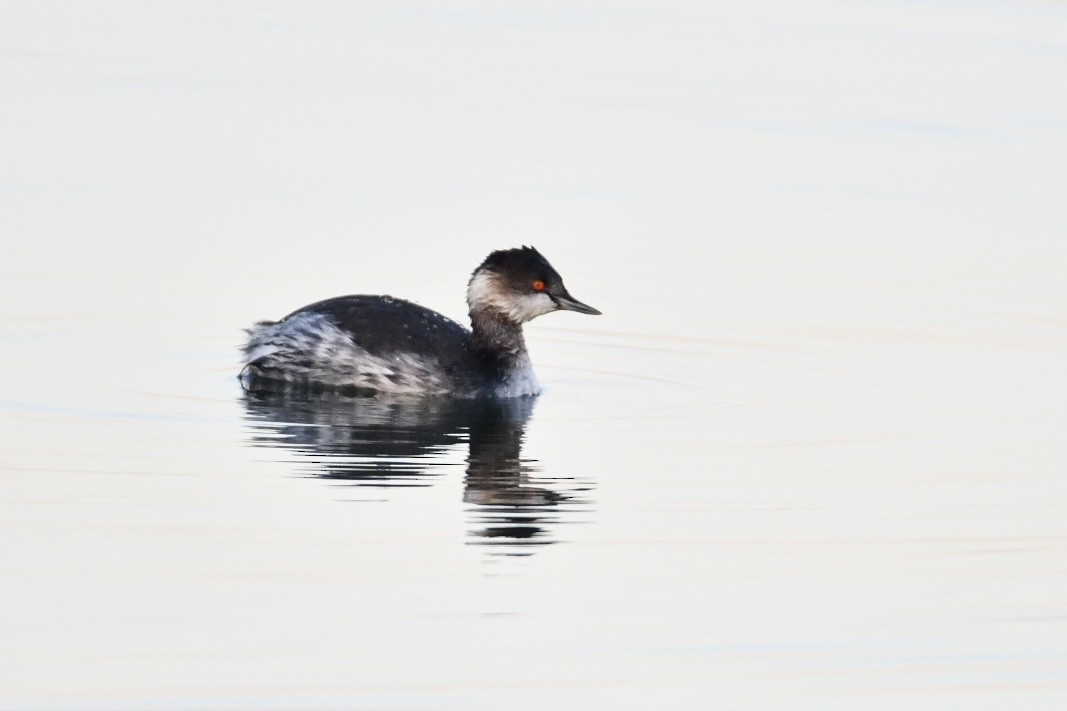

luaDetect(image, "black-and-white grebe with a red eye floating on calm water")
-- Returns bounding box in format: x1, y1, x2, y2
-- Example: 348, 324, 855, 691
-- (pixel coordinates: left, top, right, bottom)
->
241, 247, 600, 397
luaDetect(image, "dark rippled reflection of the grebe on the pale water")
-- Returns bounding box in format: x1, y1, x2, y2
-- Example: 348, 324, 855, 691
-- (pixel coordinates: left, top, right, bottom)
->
243, 393, 588, 555
